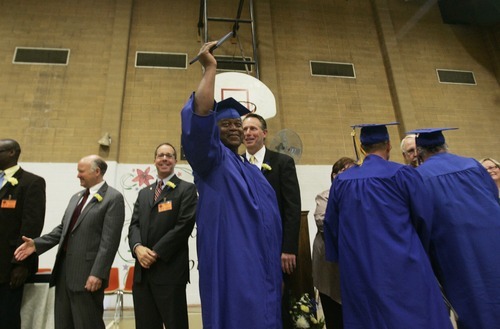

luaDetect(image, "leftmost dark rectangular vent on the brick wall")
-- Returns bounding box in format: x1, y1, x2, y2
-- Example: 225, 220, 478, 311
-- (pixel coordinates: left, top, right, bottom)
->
12, 47, 69, 65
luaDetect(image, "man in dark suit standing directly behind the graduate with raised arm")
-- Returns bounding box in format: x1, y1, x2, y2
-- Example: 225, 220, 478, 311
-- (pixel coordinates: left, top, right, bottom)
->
243, 113, 301, 328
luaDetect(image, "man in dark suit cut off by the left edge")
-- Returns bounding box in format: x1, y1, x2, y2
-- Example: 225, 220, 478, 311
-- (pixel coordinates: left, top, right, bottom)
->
0, 139, 45, 329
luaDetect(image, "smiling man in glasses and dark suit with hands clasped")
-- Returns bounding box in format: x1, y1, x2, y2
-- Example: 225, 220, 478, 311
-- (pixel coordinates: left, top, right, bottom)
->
128, 143, 198, 329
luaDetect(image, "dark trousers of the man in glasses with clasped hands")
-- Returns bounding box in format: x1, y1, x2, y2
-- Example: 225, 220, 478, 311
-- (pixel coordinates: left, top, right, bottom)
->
132, 269, 189, 329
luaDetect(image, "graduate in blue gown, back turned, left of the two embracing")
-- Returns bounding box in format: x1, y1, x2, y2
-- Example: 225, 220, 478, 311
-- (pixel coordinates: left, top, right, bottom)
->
324, 125, 452, 329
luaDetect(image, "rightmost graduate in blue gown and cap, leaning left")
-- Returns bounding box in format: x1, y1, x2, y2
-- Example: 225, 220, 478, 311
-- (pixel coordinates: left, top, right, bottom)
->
412, 128, 500, 329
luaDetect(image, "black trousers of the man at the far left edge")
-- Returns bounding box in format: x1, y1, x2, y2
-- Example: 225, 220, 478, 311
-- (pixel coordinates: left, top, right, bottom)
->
0, 282, 24, 329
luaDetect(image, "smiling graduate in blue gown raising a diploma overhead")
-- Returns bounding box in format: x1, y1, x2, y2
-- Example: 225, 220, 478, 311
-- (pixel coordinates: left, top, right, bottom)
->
181, 42, 282, 329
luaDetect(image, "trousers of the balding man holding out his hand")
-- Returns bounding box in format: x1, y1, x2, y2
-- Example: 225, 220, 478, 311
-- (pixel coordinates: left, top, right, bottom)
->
54, 259, 105, 329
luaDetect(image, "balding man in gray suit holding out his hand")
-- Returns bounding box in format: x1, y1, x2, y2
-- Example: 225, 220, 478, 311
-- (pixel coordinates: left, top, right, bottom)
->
14, 155, 125, 329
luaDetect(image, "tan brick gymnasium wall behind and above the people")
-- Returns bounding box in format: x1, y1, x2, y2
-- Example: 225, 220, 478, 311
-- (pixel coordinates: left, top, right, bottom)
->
0, 0, 500, 165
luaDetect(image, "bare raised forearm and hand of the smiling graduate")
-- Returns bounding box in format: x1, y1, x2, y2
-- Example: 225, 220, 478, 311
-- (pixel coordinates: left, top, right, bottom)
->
194, 41, 217, 115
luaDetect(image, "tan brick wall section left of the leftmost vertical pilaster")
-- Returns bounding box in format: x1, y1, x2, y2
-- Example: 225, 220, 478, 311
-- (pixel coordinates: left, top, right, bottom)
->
0, 0, 127, 162
